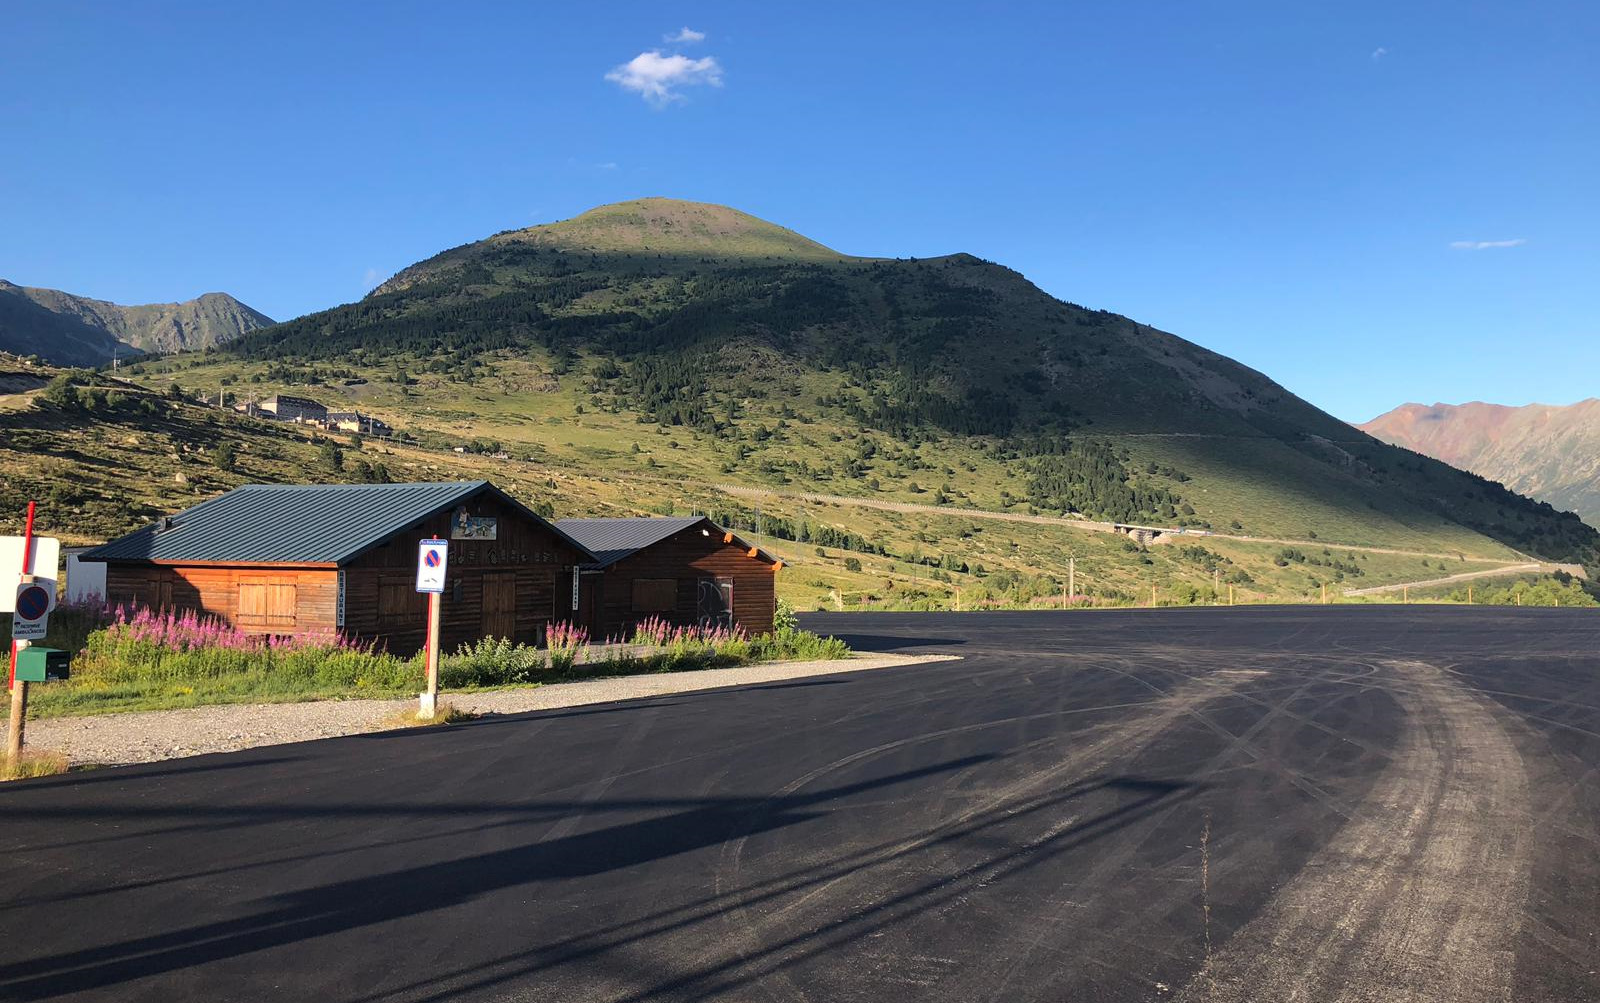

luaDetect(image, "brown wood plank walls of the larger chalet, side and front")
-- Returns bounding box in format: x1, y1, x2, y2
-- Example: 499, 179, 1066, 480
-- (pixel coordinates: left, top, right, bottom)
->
106, 496, 578, 654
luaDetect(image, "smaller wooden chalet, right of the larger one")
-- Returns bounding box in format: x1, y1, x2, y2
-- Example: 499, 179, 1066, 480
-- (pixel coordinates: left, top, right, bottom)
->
555, 517, 782, 638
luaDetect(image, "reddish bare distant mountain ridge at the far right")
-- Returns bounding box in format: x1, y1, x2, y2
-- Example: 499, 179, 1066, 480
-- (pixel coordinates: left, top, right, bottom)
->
1357, 398, 1600, 525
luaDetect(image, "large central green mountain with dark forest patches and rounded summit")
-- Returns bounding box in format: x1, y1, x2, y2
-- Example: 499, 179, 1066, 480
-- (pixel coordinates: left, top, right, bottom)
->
219, 198, 1595, 572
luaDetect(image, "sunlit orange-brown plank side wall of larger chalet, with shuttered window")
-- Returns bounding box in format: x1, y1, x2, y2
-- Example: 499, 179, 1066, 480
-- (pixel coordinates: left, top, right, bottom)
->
106, 563, 339, 633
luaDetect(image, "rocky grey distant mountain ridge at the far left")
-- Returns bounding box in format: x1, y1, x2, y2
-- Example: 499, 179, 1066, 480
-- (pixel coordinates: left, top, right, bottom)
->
0, 278, 274, 366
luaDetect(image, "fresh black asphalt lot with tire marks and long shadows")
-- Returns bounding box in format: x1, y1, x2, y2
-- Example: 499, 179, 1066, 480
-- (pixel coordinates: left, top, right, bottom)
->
0, 606, 1600, 1003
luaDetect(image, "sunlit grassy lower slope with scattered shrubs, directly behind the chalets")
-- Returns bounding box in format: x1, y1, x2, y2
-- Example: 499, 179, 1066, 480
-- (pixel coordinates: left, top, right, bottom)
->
0, 358, 1523, 608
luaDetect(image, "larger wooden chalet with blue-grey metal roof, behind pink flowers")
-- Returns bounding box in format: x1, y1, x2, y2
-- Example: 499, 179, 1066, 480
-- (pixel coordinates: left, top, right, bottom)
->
80, 480, 597, 654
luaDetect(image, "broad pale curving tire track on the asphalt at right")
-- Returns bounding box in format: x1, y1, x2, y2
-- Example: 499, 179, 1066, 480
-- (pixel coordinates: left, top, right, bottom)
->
1178, 661, 1533, 1003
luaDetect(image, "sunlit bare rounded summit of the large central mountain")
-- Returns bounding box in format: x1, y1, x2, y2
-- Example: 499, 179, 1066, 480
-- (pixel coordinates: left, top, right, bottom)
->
491, 197, 845, 261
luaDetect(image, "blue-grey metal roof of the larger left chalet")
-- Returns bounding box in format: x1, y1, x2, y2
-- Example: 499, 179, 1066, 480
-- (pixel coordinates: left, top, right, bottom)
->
82, 480, 594, 565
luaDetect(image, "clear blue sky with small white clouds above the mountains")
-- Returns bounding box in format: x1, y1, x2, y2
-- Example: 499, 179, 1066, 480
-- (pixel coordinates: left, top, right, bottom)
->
0, 0, 1600, 421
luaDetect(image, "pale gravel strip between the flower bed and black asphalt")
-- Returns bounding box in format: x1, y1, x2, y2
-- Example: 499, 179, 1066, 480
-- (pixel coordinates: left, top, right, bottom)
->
27, 654, 954, 766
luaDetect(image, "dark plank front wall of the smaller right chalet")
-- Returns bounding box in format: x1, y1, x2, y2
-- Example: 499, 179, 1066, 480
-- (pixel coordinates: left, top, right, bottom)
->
584, 526, 778, 640
